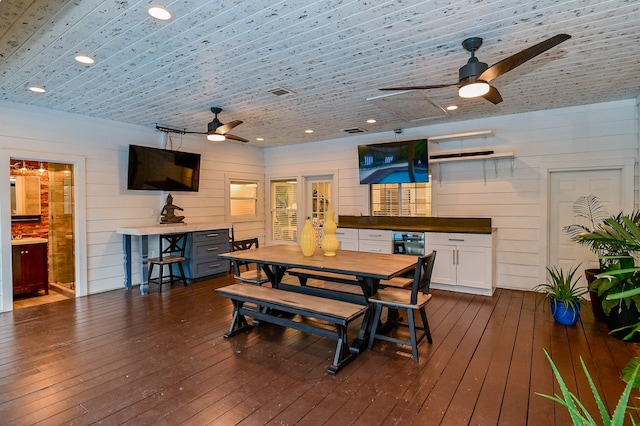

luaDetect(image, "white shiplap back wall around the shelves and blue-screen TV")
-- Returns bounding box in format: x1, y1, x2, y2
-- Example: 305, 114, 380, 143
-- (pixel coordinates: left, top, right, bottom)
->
265, 100, 639, 289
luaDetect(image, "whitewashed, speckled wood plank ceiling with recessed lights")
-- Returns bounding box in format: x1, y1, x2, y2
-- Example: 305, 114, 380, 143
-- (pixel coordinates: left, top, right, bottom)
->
0, 0, 640, 147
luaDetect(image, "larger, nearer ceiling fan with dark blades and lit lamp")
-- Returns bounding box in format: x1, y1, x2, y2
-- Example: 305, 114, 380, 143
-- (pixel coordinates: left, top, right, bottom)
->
380, 34, 571, 104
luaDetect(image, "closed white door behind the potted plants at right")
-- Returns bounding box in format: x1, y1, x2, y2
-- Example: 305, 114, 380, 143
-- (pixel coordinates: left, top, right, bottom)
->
548, 169, 623, 275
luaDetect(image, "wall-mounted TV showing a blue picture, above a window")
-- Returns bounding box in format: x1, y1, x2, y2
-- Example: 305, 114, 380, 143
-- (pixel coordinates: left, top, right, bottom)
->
358, 139, 429, 184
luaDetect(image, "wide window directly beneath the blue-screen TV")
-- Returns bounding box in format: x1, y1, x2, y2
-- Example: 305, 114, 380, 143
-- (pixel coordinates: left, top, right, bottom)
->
371, 182, 431, 217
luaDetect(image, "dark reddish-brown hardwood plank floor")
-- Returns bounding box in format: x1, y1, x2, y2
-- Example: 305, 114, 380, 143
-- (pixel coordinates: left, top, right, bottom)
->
0, 276, 640, 425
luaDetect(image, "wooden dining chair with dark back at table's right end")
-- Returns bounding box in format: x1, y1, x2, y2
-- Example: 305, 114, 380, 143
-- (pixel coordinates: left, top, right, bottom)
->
368, 250, 436, 362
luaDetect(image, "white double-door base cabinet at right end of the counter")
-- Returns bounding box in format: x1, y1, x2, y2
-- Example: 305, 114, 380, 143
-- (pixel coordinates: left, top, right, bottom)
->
425, 232, 495, 295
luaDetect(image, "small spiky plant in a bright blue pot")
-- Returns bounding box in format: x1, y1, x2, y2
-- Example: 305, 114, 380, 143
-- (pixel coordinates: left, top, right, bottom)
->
533, 265, 588, 325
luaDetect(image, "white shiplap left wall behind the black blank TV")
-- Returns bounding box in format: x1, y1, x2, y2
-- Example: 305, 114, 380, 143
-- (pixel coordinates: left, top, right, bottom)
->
0, 102, 264, 310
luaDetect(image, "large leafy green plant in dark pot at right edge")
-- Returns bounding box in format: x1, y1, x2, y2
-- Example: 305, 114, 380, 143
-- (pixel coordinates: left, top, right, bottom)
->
577, 212, 640, 341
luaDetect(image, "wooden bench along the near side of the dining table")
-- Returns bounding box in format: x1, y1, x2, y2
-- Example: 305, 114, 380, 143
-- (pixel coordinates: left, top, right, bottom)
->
216, 284, 367, 374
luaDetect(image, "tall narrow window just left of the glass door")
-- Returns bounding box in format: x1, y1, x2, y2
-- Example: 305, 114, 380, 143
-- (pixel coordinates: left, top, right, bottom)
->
271, 179, 298, 241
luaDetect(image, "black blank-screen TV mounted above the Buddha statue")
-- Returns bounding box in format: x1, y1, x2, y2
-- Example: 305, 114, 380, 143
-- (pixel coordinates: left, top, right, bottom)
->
127, 145, 200, 192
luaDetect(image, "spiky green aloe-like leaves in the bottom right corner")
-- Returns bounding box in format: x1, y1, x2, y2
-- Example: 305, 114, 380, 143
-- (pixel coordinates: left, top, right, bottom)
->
536, 350, 640, 426
